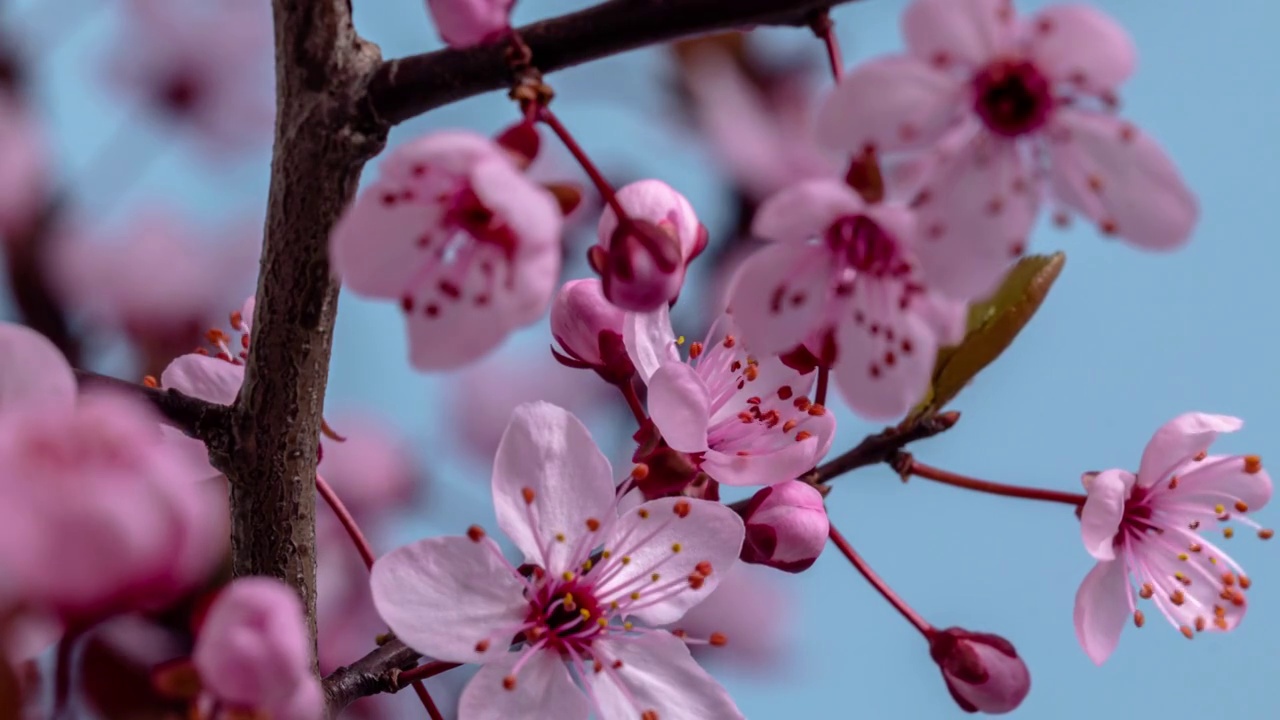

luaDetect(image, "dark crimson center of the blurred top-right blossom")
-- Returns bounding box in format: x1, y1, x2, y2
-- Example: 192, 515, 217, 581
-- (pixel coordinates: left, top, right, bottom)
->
972, 58, 1055, 137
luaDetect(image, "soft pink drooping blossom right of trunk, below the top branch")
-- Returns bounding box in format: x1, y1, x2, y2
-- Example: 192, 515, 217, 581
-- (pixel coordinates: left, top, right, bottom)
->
332, 131, 563, 370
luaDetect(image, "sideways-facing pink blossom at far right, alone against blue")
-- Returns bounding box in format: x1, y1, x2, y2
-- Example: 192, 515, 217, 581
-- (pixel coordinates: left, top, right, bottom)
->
1075, 413, 1272, 665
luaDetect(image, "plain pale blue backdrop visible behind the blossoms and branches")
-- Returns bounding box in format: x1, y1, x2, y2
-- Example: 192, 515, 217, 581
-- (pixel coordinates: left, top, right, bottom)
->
3, 0, 1280, 720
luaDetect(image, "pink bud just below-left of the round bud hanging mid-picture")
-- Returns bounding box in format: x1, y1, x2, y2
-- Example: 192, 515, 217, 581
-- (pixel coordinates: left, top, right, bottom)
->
552, 278, 635, 383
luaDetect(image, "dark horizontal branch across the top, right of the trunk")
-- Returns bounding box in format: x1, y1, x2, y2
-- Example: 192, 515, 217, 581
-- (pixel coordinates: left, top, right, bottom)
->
365, 0, 852, 126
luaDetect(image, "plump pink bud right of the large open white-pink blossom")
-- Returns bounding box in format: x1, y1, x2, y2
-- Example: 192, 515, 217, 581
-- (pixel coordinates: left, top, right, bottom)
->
742, 480, 829, 573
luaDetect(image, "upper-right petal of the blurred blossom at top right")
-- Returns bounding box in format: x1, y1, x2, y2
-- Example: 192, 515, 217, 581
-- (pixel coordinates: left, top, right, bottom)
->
1024, 5, 1138, 94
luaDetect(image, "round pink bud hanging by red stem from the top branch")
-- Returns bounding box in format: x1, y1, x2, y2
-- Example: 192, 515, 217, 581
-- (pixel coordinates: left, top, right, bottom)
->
588, 179, 707, 313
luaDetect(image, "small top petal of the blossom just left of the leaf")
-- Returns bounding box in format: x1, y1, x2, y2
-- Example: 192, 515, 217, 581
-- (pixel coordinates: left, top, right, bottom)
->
751, 179, 865, 242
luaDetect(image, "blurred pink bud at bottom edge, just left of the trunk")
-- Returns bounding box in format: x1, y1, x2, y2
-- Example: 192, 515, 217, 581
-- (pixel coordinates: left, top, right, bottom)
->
192, 578, 324, 720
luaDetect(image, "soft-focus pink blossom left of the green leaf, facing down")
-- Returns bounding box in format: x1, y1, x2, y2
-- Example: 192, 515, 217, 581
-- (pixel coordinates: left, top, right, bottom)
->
730, 181, 965, 420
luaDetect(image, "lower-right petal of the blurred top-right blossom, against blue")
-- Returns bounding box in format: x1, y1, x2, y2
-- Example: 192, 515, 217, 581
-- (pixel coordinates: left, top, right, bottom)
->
1048, 109, 1199, 250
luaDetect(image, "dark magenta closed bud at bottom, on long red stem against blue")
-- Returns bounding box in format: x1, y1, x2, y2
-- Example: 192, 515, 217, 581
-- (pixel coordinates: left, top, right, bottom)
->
929, 628, 1032, 715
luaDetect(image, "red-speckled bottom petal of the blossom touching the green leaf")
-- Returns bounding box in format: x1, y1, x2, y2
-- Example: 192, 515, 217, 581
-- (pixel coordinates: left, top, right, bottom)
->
833, 298, 938, 421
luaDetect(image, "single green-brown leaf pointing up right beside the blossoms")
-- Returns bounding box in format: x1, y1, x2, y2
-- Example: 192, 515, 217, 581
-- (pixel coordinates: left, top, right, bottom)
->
904, 252, 1066, 425
